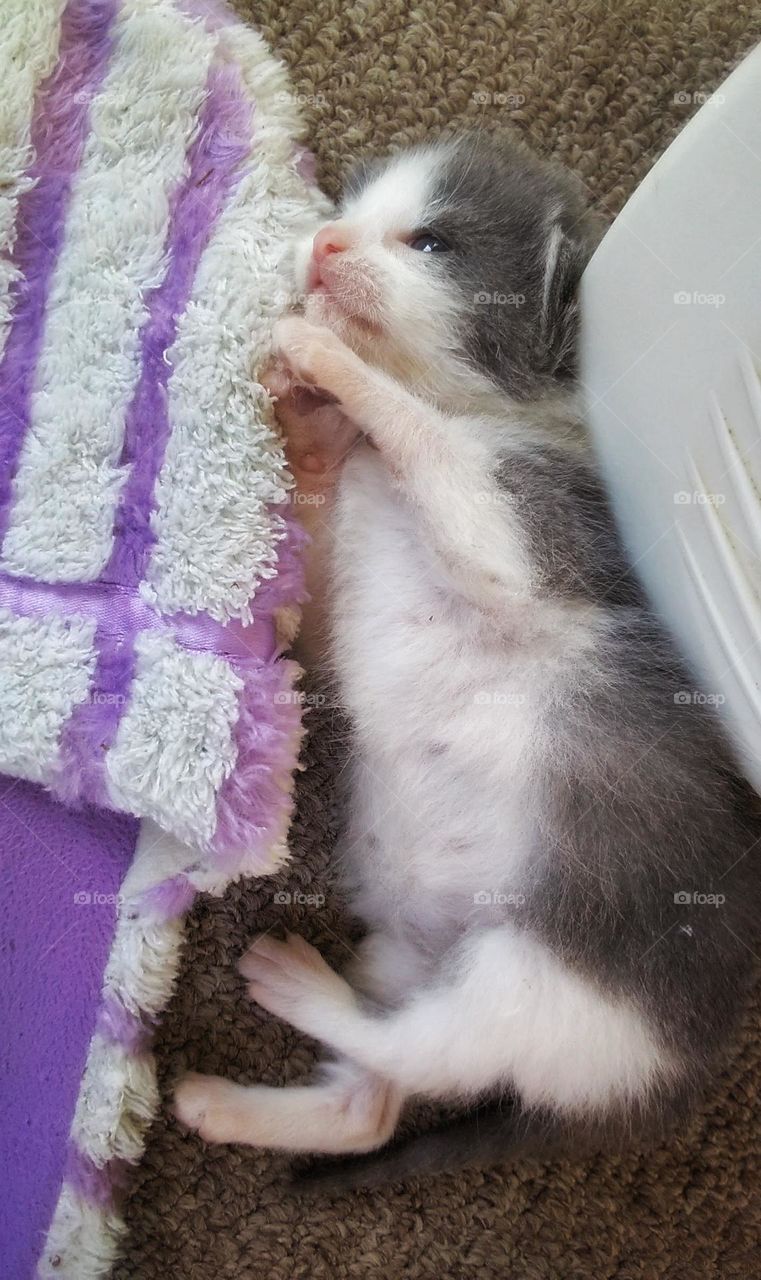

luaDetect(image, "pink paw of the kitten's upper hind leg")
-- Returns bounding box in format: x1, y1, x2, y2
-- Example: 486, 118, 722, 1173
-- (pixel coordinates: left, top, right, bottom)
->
238, 933, 354, 1039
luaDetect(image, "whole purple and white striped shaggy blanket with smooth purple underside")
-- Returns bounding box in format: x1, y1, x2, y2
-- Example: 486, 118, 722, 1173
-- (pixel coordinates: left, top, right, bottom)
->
0, 0, 324, 1280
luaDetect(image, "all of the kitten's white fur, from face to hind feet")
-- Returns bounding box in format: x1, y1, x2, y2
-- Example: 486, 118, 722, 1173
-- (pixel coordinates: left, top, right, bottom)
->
178, 162, 678, 1151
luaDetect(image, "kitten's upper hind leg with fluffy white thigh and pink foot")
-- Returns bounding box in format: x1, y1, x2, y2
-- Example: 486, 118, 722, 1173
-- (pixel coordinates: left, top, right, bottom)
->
240, 928, 678, 1111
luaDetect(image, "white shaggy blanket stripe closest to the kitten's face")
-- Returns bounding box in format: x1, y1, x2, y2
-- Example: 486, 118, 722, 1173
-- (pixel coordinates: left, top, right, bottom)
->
142, 18, 327, 622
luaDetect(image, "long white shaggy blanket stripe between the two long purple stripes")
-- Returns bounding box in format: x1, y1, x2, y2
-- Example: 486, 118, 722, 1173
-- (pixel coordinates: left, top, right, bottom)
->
3, 0, 215, 582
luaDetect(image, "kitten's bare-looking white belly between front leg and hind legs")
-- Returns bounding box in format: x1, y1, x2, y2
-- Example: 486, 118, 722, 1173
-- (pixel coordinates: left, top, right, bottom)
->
333, 453, 536, 941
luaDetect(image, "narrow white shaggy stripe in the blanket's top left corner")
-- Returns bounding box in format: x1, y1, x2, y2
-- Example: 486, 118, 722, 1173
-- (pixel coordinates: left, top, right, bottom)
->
0, 0, 65, 360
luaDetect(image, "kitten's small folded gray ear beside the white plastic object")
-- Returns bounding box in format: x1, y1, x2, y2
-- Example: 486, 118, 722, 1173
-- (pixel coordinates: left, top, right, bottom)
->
542, 212, 602, 379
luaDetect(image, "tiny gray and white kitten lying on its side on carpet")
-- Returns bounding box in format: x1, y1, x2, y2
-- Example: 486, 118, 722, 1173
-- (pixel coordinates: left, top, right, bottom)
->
177, 138, 761, 1188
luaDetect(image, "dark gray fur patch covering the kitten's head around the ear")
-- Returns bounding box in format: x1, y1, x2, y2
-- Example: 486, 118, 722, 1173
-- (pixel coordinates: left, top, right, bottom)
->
428, 136, 596, 399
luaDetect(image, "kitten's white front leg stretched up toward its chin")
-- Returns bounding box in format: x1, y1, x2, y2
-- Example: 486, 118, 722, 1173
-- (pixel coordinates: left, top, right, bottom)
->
275, 316, 535, 611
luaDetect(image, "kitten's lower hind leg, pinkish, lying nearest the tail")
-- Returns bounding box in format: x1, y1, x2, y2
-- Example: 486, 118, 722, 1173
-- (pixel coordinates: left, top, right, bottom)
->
174, 1062, 402, 1155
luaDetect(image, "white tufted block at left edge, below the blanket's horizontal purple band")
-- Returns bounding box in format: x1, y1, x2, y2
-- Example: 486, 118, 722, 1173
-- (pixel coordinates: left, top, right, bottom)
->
0, 609, 96, 782
